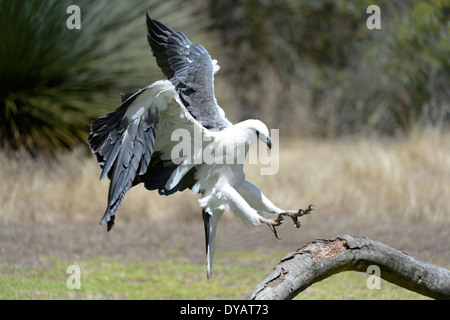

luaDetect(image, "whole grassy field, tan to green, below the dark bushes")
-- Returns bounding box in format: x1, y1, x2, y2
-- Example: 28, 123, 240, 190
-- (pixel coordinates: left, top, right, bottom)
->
0, 130, 450, 299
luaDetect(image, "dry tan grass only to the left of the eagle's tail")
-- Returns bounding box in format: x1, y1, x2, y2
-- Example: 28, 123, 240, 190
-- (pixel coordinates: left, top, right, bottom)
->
0, 149, 200, 223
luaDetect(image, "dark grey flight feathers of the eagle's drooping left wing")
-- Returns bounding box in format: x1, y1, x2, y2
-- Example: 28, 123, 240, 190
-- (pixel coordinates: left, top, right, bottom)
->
88, 90, 159, 231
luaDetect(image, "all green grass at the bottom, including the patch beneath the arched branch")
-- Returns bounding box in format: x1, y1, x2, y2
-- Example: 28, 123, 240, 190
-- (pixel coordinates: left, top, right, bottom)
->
0, 251, 432, 300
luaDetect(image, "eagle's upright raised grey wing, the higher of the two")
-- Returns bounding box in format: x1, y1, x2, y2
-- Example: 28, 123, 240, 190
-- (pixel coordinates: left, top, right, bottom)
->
147, 14, 231, 131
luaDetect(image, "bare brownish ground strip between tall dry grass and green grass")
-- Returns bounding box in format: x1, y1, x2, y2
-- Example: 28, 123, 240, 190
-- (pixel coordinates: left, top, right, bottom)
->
0, 212, 450, 267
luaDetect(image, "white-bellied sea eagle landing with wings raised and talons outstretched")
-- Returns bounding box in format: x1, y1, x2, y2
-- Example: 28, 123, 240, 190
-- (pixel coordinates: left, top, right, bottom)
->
88, 14, 312, 278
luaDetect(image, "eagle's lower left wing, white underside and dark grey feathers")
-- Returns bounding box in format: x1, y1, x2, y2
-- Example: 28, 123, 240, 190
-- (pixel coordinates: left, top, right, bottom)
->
88, 81, 207, 230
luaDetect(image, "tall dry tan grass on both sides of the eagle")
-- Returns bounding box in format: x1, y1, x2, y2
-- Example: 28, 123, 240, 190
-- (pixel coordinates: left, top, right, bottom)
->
0, 130, 450, 228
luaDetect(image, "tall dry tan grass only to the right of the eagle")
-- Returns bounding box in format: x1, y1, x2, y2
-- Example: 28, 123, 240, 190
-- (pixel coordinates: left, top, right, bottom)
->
246, 126, 450, 223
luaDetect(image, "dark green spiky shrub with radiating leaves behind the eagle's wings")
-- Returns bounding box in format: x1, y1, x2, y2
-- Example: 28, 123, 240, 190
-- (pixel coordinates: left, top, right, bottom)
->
0, 0, 211, 155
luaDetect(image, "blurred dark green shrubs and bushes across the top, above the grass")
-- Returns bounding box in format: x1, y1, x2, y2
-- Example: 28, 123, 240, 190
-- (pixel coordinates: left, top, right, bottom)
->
0, 0, 450, 156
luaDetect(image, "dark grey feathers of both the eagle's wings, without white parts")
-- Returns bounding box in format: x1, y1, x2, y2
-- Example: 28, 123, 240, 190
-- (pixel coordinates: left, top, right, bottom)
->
88, 15, 231, 231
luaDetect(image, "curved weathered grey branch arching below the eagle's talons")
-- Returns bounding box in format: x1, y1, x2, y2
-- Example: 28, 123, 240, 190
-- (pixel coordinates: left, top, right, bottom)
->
247, 235, 450, 300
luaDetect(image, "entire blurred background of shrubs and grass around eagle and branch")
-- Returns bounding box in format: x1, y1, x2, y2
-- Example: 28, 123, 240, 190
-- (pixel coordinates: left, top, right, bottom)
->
0, 0, 450, 299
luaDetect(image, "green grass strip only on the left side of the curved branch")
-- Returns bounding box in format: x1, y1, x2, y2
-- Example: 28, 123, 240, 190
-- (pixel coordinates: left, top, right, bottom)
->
0, 253, 264, 299
